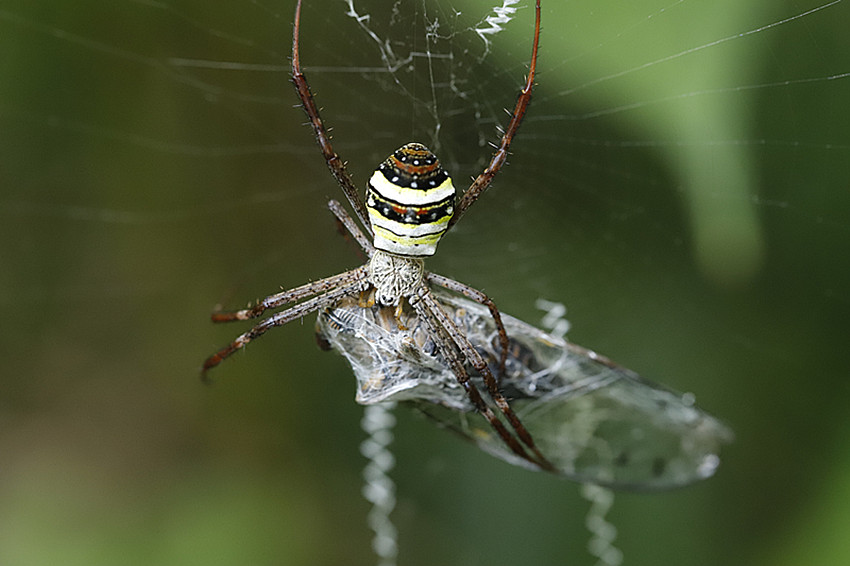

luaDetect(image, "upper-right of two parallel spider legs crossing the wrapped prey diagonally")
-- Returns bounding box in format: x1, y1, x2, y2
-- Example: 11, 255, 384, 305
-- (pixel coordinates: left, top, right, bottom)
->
414, 287, 555, 471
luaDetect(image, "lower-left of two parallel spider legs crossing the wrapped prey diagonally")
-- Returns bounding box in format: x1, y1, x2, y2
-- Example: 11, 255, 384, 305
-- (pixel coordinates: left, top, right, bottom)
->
410, 287, 539, 465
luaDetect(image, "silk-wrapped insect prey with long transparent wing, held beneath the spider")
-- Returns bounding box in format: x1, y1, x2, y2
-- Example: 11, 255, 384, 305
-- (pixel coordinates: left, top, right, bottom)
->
317, 290, 732, 489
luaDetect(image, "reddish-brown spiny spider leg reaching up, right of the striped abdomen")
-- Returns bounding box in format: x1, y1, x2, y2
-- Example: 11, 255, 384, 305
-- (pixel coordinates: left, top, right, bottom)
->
447, 0, 540, 230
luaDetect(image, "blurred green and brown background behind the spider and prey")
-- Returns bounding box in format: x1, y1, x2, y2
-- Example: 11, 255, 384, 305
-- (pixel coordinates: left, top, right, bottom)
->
0, 0, 850, 566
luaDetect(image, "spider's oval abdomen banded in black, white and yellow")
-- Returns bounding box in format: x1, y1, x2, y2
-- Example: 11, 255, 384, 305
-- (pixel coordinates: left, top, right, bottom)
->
366, 143, 455, 257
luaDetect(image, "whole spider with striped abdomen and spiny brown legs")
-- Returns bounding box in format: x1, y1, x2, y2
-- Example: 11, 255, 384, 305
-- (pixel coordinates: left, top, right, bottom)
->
202, 0, 556, 471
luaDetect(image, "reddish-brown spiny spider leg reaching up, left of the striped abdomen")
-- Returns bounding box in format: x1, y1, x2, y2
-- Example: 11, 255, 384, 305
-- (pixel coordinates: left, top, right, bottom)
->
292, 0, 371, 233
